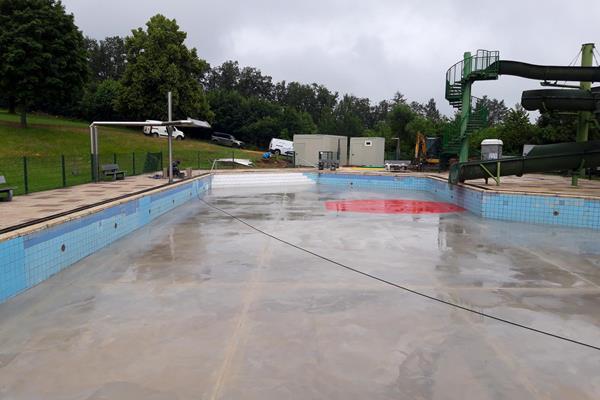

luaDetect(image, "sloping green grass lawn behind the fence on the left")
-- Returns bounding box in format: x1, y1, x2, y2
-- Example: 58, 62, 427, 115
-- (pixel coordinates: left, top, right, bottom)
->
0, 110, 262, 194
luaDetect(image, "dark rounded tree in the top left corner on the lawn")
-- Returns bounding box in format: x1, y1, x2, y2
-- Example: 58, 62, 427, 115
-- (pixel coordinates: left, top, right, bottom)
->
0, 0, 87, 126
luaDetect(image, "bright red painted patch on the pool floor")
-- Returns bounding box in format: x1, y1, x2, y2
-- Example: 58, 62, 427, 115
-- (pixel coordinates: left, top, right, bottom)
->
325, 200, 465, 214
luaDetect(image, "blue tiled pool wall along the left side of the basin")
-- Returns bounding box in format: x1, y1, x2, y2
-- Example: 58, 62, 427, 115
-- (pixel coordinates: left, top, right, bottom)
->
0, 176, 211, 303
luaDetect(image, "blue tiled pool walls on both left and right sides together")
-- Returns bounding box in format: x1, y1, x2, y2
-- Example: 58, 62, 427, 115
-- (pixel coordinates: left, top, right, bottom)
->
0, 172, 600, 303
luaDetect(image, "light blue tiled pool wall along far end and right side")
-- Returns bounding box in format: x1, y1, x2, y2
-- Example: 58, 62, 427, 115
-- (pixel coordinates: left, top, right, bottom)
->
306, 173, 600, 230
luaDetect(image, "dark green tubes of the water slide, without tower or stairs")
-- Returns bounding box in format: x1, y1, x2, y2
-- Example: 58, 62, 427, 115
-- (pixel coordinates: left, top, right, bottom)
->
448, 60, 600, 184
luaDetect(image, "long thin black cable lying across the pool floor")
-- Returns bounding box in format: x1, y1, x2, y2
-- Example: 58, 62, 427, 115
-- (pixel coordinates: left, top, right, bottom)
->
200, 199, 600, 351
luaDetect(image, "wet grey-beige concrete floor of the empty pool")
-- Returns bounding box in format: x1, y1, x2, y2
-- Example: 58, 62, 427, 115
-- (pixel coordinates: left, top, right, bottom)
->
0, 185, 600, 400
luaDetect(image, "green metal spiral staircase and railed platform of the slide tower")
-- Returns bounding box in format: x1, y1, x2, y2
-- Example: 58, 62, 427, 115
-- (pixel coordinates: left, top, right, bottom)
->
442, 50, 500, 158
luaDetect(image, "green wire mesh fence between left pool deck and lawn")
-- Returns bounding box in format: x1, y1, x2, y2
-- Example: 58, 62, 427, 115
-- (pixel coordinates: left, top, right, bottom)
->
0, 150, 227, 195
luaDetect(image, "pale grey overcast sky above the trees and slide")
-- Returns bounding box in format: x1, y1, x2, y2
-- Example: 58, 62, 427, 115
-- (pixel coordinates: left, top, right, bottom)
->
63, 0, 600, 114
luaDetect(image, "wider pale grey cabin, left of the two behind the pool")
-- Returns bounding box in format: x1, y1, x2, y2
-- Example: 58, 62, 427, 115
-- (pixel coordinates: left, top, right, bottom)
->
294, 135, 348, 167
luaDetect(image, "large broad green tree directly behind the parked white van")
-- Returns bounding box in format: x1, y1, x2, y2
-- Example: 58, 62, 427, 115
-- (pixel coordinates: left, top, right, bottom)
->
117, 14, 214, 121
